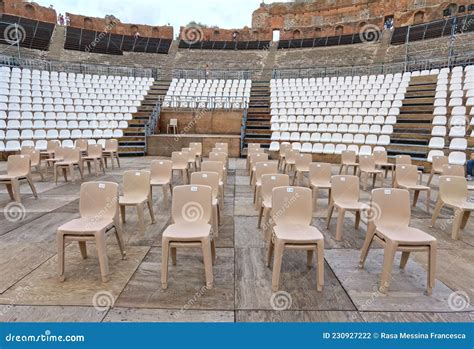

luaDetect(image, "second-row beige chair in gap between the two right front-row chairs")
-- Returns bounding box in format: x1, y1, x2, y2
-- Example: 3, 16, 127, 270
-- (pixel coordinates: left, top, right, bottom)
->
327, 176, 369, 241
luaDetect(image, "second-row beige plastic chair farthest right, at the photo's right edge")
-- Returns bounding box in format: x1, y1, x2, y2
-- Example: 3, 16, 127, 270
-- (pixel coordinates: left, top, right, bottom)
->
431, 175, 474, 240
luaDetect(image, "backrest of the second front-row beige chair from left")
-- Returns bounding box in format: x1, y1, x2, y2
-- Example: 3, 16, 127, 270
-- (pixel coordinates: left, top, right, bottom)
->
171, 184, 212, 225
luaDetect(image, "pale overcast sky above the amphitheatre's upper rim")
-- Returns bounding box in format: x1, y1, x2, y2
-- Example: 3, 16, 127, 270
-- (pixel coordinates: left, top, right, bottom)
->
36, 0, 289, 34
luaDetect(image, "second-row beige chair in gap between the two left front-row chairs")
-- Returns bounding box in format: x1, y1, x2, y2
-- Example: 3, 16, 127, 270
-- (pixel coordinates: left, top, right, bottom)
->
119, 170, 155, 232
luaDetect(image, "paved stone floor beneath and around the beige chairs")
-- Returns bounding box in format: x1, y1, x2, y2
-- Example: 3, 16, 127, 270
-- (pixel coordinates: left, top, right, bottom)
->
0, 157, 474, 322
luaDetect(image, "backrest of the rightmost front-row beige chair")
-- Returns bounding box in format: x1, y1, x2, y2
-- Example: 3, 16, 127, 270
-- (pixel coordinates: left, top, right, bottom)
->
368, 188, 411, 227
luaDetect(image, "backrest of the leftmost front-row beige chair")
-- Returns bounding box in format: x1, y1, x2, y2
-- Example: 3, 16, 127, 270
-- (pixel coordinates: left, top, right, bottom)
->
79, 182, 118, 221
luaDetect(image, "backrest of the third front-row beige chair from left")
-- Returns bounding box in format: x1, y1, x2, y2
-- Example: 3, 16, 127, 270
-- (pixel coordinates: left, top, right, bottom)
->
271, 186, 313, 226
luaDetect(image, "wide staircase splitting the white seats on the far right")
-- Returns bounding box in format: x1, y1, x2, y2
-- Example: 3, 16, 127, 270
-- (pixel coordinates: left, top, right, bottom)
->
387, 76, 437, 166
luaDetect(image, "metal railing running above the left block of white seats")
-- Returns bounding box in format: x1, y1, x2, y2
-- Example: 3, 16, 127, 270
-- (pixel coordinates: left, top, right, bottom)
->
0, 55, 159, 79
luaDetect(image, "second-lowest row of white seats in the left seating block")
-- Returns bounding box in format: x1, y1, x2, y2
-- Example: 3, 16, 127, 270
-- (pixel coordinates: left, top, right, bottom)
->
0, 129, 123, 141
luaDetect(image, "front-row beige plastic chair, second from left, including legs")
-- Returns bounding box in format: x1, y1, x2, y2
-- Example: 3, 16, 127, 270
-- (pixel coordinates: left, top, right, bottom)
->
161, 185, 216, 289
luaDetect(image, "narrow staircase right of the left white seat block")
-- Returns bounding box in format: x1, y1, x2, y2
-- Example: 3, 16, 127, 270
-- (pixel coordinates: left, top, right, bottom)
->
119, 80, 171, 156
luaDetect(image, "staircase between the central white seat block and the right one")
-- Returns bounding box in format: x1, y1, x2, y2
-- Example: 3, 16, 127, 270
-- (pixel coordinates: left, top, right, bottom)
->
244, 80, 271, 148
